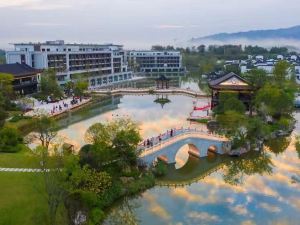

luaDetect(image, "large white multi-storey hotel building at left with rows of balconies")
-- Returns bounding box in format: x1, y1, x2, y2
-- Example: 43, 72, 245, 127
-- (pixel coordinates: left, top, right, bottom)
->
6, 40, 132, 87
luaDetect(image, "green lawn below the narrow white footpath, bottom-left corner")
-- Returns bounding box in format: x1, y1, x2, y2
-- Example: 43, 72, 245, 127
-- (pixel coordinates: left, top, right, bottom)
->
0, 172, 67, 225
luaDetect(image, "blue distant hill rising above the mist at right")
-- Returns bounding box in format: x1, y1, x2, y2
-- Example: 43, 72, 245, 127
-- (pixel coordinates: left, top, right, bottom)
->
190, 25, 300, 43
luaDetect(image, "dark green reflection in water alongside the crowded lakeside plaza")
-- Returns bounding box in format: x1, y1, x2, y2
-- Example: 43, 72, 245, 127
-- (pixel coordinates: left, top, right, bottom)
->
59, 95, 122, 128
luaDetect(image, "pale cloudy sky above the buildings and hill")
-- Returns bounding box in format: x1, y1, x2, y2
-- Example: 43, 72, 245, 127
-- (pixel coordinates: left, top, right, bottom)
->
0, 0, 300, 49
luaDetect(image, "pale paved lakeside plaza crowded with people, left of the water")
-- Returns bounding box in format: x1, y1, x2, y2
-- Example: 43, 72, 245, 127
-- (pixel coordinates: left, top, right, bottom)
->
25, 98, 91, 117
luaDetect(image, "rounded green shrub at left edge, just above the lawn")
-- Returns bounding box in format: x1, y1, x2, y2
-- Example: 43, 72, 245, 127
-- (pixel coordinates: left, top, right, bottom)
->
0, 127, 23, 152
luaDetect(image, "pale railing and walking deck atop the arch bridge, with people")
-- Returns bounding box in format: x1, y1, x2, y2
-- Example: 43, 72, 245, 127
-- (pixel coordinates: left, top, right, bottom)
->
138, 128, 227, 156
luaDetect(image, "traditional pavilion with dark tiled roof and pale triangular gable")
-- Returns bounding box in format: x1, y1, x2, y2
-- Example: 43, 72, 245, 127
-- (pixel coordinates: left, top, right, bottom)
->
208, 73, 253, 109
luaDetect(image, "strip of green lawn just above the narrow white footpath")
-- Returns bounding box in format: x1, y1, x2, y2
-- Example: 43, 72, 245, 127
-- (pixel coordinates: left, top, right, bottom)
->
0, 148, 39, 168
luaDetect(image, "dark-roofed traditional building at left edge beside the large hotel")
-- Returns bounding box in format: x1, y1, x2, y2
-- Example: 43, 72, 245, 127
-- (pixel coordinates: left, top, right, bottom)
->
0, 63, 41, 95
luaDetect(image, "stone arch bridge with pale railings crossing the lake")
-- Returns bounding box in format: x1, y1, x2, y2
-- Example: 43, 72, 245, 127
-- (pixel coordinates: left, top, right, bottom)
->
139, 129, 231, 165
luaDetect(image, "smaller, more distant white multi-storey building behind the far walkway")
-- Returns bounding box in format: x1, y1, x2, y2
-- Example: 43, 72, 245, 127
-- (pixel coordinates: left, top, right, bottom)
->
126, 51, 186, 76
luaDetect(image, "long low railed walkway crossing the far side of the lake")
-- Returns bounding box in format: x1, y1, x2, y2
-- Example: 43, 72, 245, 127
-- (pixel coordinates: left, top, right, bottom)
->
89, 87, 209, 98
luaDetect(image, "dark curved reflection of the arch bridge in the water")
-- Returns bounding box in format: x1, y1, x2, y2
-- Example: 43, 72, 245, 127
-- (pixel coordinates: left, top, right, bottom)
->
157, 153, 230, 186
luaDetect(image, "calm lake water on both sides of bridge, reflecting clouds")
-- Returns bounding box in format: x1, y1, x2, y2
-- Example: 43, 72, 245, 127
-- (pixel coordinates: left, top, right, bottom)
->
60, 79, 300, 225
